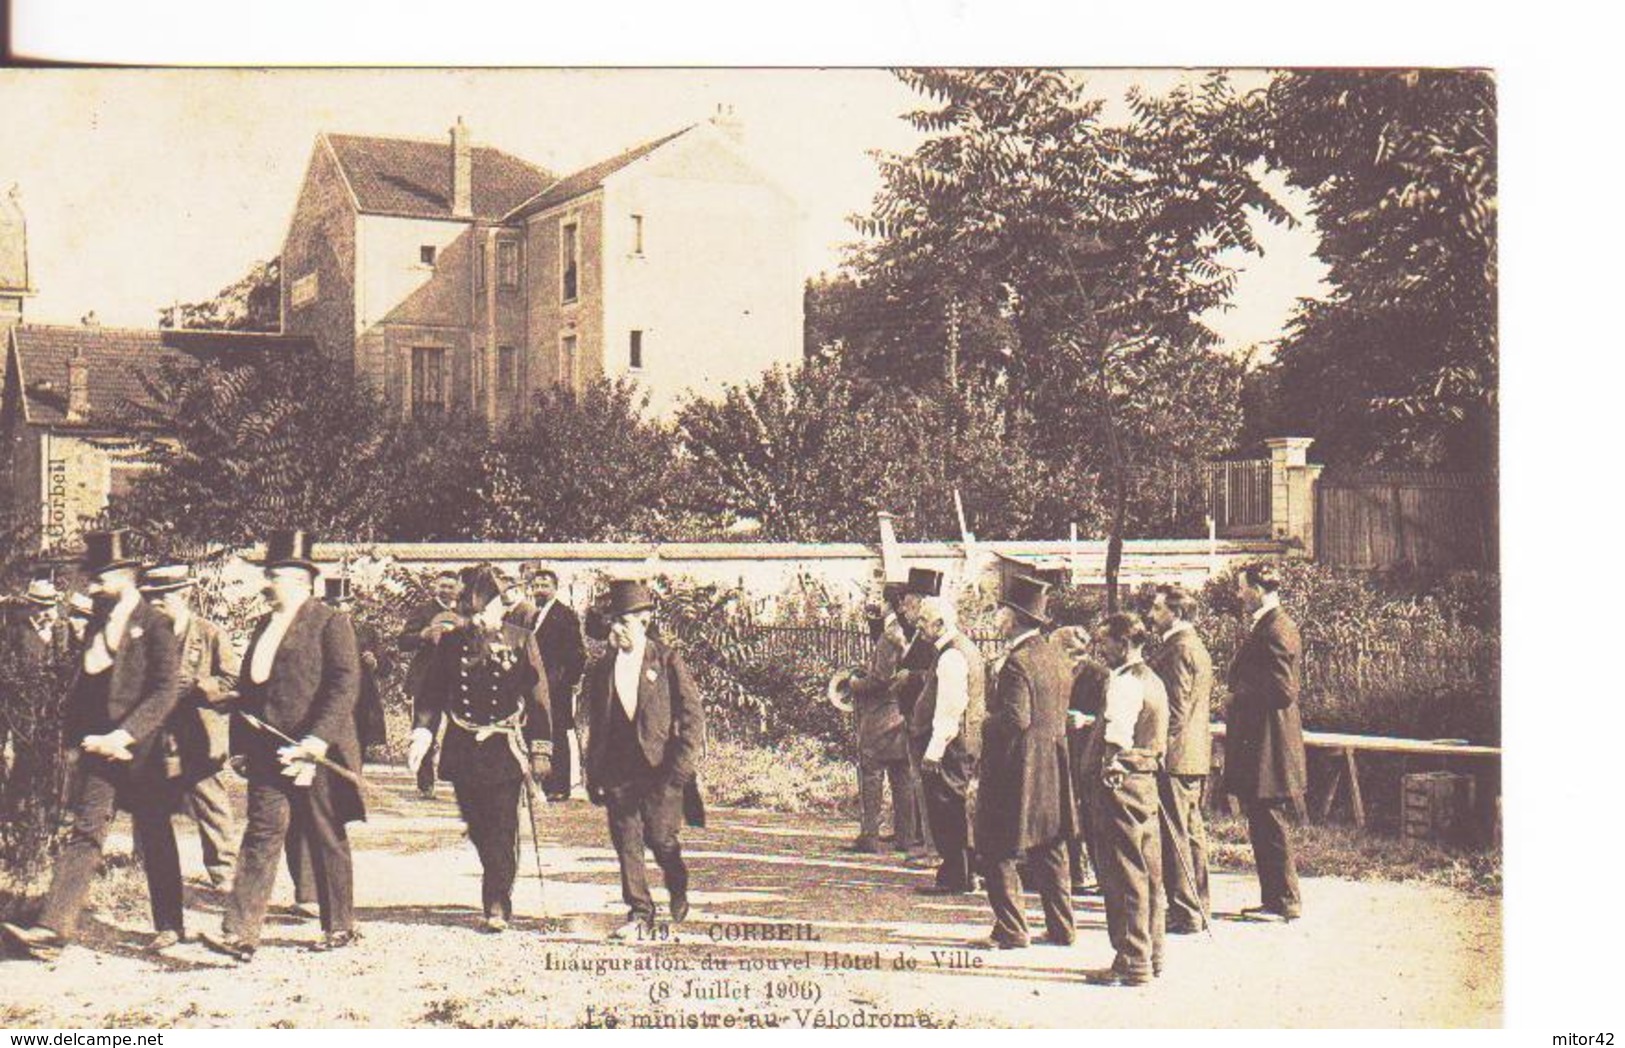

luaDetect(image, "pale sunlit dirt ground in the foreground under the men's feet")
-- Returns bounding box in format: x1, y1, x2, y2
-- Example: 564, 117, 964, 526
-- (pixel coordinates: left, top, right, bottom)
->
0, 770, 1502, 1029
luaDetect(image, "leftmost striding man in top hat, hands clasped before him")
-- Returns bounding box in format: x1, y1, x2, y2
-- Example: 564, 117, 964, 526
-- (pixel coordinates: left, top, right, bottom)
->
3, 531, 184, 960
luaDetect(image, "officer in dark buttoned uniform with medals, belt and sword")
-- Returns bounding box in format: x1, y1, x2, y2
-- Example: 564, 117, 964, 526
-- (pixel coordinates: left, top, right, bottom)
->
406, 564, 553, 933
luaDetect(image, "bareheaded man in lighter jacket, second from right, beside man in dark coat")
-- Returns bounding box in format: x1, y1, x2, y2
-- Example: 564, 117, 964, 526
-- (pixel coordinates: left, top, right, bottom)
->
1147, 585, 1214, 934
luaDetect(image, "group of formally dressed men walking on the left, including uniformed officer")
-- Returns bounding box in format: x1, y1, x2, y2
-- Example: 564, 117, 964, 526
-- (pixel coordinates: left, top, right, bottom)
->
0, 531, 705, 964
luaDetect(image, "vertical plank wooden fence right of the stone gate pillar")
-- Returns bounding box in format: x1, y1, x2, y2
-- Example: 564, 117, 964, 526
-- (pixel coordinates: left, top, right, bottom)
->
1315, 471, 1498, 570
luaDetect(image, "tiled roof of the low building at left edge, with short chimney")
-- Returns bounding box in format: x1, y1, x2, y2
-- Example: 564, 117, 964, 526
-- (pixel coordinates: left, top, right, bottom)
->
11, 323, 315, 427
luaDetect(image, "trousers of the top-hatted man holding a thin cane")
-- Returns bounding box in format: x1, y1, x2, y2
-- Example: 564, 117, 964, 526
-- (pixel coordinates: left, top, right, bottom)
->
224, 769, 356, 946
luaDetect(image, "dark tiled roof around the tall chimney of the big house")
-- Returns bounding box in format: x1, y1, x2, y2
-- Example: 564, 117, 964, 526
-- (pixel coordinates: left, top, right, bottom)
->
327, 135, 557, 221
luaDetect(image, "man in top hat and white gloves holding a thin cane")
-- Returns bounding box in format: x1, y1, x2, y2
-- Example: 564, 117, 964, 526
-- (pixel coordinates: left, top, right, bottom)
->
206, 531, 366, 962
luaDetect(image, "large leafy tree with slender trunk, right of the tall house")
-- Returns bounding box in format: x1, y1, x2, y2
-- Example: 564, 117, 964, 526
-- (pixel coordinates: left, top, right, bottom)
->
856, 70, 1290, 601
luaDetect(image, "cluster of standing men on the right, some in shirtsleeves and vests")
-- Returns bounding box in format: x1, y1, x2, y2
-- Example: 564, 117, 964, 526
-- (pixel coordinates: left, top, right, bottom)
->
832, 564, 1307, 986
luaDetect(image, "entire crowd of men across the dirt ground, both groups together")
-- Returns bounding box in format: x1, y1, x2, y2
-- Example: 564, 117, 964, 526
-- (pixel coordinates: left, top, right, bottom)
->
0, 531, 1305, 986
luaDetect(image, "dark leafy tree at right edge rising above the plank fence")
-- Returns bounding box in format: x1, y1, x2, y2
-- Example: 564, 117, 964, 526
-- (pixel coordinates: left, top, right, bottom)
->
1269, 70, 1498, 470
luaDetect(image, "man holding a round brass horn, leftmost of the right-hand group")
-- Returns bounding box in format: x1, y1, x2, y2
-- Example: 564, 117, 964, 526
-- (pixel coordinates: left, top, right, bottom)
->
850, 582, 923, 855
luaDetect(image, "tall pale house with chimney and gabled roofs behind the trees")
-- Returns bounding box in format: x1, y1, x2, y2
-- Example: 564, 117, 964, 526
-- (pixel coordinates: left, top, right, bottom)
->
283, 107, 801, 421
